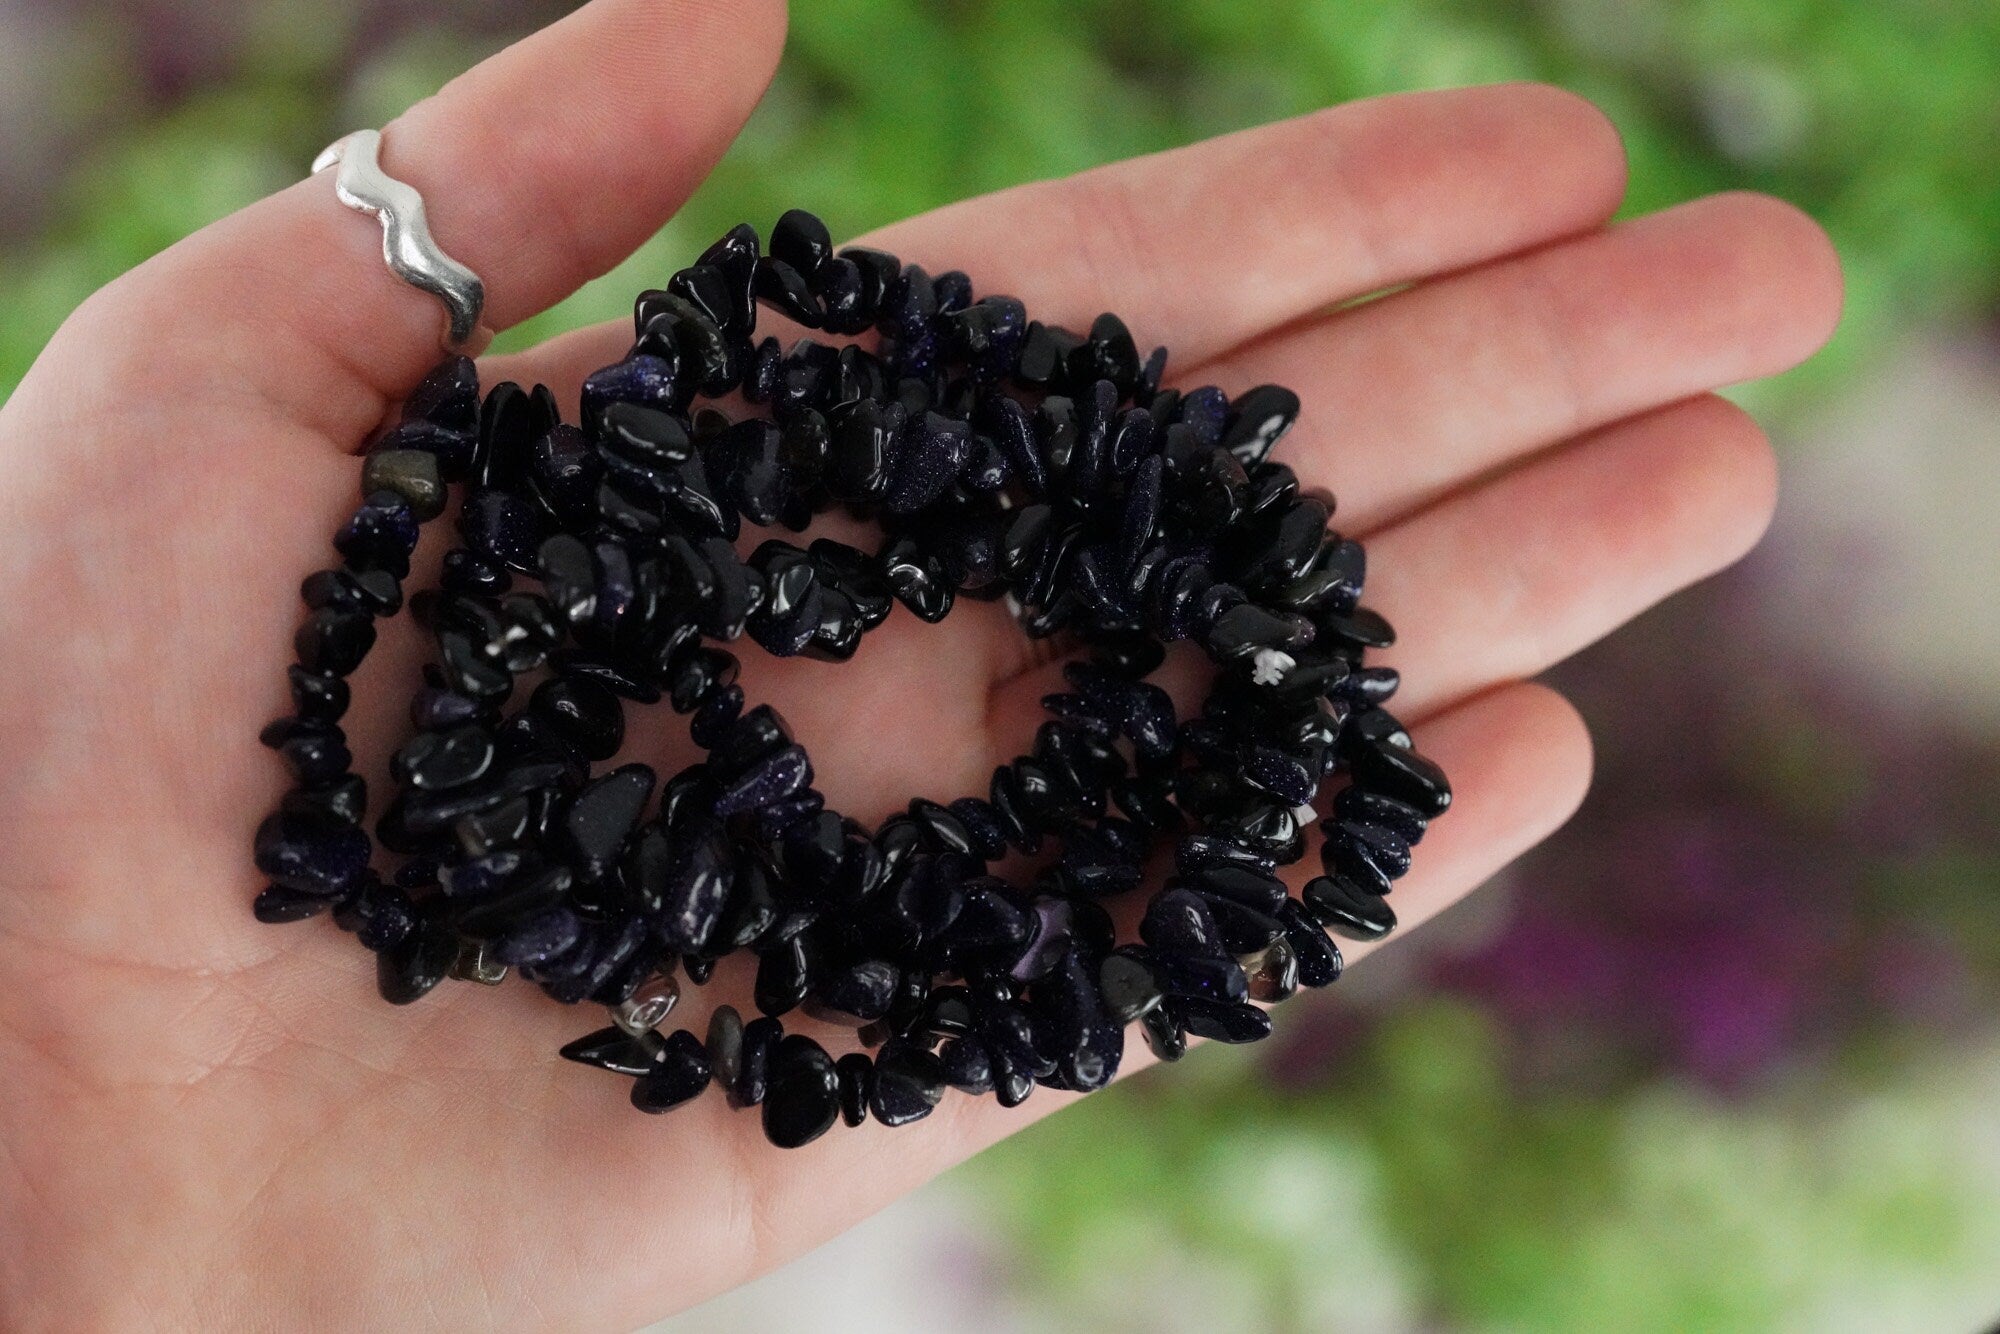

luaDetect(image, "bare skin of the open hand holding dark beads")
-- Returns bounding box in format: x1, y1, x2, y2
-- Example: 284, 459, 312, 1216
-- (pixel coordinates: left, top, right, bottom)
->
0, 0, 1840, 1330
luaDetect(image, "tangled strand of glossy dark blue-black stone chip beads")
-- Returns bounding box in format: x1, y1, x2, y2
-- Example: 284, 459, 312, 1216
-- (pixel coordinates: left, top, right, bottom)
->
256, 210, 1450, 1148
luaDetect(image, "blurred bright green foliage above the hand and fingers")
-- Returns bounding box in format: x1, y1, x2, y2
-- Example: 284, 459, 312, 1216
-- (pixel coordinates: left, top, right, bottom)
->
0, 0, 2000, 418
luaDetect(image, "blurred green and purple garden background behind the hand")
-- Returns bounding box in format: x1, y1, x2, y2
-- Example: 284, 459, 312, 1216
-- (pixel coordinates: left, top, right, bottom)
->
0, 0, 2000, 1334
